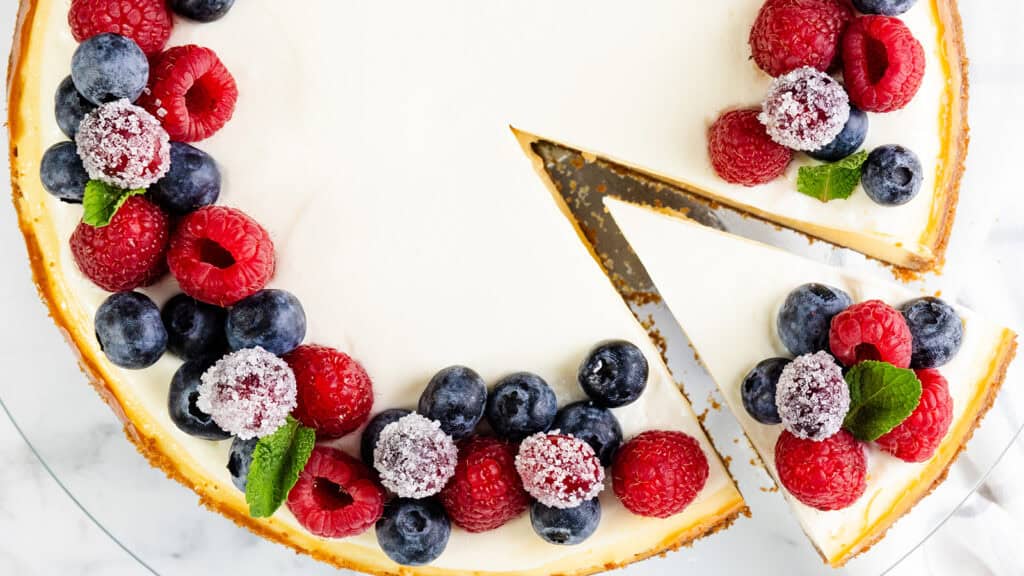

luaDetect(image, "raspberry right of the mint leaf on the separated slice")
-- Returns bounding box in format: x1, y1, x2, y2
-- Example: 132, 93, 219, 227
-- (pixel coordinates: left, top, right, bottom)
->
874, 369, 953, 462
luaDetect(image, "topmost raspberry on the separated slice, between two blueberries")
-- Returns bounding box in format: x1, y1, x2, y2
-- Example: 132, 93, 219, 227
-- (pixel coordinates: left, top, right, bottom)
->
828, 300, 913, 368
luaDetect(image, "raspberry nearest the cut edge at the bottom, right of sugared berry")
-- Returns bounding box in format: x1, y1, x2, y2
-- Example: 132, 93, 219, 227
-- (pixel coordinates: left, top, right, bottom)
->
611, 430, 708, 518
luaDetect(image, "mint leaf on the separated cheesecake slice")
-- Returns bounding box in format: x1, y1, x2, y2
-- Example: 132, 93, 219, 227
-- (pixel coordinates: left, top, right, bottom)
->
843, 361, 921, 442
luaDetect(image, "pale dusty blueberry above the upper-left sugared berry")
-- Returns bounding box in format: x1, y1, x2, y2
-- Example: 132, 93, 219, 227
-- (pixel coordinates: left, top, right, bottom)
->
71, 34, 150, 105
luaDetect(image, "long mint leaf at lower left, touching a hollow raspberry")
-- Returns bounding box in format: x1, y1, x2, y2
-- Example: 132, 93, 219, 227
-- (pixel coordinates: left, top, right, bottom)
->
246, 416, 316, 518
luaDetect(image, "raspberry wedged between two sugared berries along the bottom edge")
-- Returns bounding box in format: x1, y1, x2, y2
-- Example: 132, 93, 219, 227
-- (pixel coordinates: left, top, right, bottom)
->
440, 437, 529, 532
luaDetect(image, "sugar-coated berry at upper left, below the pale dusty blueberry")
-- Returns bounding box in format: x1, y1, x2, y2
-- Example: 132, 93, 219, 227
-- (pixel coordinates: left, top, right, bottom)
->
75, 99, 171, 190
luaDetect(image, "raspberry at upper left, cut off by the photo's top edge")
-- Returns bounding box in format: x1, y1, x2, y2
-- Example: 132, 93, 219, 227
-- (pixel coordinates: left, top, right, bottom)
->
68, 0, 174, 54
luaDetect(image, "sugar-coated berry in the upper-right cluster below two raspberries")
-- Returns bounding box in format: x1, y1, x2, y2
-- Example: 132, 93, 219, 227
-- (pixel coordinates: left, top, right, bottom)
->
759, 67, 850, 151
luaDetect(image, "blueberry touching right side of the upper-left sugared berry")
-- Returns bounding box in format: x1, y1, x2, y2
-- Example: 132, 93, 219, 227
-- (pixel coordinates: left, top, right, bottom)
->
148, 142, 220, 216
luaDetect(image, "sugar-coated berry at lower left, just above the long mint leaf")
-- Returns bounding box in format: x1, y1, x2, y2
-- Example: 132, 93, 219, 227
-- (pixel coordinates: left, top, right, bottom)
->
196, 347, 295, 440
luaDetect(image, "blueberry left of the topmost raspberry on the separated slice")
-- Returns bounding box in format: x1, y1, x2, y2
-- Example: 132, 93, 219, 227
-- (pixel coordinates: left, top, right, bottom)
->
776, 284, 853, 356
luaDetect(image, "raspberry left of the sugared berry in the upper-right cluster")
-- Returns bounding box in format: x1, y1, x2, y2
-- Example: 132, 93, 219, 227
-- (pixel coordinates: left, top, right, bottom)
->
708, 110, 793, 187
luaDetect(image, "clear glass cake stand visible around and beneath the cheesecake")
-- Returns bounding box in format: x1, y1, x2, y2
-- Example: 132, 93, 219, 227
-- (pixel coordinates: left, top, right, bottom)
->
0, 0, 1024, 576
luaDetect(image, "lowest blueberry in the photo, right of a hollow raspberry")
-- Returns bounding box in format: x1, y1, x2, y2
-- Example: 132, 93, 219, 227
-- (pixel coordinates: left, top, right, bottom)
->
374, 498, 452, 566
